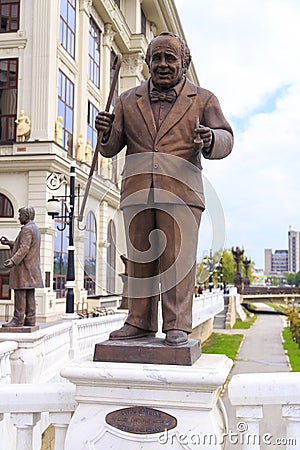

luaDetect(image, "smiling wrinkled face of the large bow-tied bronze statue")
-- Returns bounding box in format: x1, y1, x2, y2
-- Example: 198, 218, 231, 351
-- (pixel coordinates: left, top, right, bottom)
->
149, 36, 184, 90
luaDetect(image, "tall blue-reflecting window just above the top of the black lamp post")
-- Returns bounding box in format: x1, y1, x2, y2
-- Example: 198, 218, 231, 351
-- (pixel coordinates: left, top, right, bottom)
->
57, 71, 74, 156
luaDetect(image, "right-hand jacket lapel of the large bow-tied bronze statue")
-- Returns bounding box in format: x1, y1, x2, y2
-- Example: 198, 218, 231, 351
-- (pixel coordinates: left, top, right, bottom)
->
156, 80, 197, 141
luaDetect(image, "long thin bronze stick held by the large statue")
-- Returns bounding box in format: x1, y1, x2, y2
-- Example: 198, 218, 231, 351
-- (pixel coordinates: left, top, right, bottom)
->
77, 54, 122, 222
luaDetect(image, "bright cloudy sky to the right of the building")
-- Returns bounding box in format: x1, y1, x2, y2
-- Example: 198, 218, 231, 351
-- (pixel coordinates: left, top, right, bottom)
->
175, 0, 300, 268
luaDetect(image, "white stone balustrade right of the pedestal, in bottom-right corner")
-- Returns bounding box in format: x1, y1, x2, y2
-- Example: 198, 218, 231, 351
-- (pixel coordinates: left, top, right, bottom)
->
228, 372, 300, 450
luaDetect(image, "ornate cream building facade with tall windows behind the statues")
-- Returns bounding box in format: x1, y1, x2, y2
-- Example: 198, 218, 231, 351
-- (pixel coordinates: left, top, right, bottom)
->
0, 0, 197, 321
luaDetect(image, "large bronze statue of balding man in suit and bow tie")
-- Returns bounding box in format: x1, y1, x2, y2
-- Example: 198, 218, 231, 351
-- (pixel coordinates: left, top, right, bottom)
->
96, 32, 233, 346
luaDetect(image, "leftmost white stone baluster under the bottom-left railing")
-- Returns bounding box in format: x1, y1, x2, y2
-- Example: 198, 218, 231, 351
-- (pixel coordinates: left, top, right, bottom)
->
11, 412, 41, 450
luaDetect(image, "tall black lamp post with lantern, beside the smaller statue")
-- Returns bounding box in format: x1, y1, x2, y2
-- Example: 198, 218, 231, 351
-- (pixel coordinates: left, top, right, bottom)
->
47, 161, 77, 318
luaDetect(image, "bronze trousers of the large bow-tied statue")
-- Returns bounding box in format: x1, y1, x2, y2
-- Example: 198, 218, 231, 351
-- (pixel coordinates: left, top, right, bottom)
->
123, 202, 202, 333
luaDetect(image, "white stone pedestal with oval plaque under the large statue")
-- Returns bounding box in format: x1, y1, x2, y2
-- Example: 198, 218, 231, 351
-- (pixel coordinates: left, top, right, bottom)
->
61, 355, 232, 450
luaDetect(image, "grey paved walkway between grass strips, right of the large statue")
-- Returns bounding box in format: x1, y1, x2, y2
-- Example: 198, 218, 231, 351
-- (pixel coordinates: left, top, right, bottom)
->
220, 303, 290, 450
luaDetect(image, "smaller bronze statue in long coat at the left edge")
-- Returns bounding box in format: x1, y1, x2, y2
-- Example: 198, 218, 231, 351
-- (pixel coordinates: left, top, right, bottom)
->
1, 206, 43, 327
